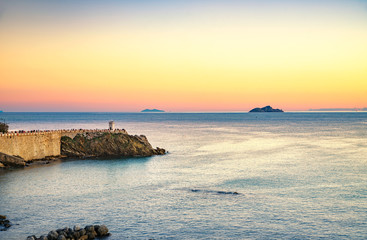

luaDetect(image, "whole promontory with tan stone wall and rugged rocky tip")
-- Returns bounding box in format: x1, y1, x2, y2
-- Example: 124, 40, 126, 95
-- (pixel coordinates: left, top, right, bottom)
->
0, 129, 166, 169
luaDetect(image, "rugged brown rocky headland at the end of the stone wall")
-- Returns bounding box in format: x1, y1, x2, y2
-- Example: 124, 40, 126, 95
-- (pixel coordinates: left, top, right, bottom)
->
61, 132, 166, 158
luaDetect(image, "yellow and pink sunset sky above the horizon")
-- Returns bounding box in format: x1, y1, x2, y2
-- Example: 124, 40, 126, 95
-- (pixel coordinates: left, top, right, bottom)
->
0, 0, 367, 112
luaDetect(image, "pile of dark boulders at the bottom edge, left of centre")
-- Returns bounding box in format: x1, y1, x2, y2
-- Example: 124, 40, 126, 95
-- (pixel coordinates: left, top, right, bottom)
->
26, 225, 110, 240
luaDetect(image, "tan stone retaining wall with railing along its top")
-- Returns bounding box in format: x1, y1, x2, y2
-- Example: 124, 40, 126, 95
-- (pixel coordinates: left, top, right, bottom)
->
0, 129, 127, 161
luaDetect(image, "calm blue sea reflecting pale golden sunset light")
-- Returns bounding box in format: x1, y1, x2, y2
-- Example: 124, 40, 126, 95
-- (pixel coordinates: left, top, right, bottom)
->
0, 112, 367, 240
